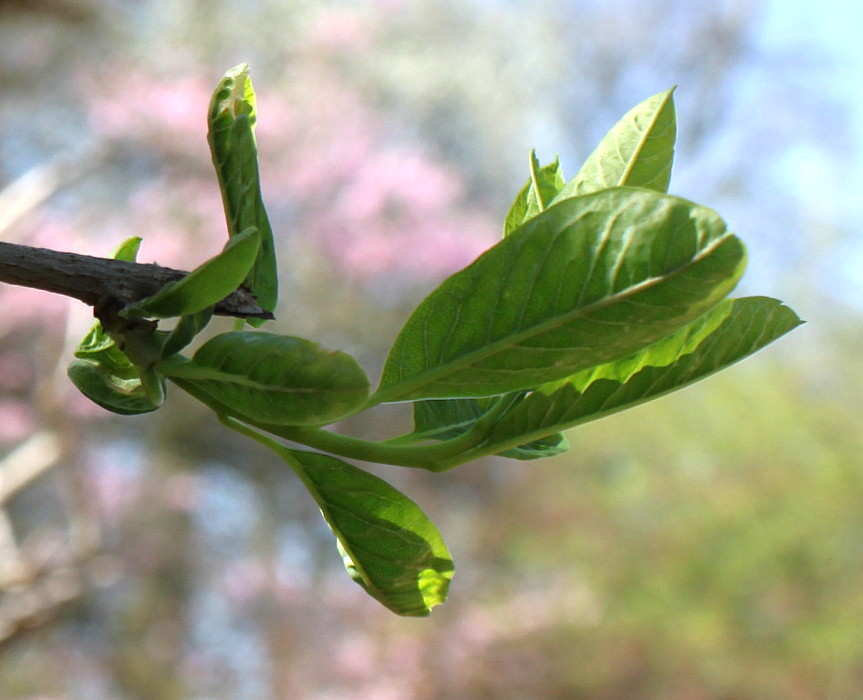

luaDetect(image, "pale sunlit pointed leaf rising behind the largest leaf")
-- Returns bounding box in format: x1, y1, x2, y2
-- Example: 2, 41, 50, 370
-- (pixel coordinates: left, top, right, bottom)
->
556, 88, 677, 201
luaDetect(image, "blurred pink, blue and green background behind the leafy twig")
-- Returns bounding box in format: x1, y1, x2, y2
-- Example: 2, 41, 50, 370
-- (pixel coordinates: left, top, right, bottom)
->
0, 0, 863, 700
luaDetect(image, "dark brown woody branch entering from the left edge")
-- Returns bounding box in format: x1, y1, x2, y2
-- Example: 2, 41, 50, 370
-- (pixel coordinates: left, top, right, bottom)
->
0, 243, 273, 319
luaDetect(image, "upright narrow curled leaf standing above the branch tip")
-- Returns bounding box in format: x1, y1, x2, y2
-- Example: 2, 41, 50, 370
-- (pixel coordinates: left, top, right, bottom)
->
207, 63, 279, 325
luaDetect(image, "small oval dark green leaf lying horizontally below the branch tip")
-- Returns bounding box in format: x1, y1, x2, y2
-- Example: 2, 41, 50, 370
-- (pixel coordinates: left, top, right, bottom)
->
157, 331, 369, 425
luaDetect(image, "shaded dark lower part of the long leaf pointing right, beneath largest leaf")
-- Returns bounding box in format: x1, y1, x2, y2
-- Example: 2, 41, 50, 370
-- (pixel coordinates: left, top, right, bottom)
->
472, 297, 801, 453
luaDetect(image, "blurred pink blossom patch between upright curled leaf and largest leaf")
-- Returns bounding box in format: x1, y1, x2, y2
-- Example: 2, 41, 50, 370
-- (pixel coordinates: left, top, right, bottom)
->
259, 73, 499, 281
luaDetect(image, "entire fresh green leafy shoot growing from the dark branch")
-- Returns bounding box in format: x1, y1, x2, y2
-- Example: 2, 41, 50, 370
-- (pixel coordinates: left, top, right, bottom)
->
69, 65, 800, 616
